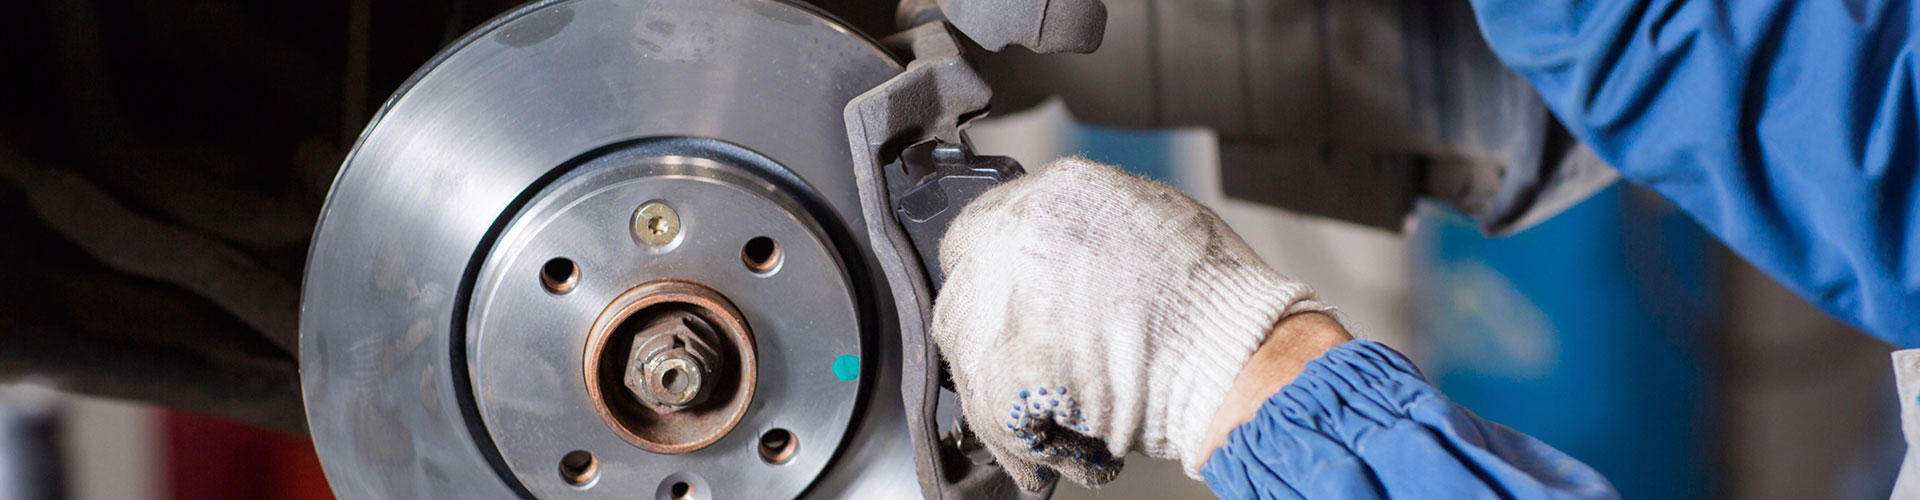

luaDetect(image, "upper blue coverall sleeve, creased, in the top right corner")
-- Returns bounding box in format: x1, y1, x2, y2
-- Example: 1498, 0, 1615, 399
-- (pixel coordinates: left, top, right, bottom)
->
1473, 0, 1920, 348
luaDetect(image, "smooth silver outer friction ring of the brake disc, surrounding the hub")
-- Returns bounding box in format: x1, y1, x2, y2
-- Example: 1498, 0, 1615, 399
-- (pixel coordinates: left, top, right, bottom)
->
300, 0, 918, 498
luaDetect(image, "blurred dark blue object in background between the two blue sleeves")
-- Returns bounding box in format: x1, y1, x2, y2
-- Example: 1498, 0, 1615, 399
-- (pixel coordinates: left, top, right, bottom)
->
1411, 185, 1724, 498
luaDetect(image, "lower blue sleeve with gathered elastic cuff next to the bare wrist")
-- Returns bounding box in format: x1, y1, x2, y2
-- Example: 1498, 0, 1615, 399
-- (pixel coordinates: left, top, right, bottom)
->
1200, 340, 1619, 498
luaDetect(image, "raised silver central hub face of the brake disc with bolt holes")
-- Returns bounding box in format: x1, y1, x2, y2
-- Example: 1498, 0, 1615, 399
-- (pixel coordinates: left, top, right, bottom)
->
468, 154, 860, 498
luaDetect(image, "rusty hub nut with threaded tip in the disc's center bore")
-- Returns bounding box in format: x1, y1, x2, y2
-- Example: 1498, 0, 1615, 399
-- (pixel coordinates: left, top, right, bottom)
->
624, 312, 720, 413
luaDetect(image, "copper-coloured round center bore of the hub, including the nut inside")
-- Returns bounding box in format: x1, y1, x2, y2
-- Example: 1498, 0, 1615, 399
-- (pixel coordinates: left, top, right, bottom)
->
584, 279, 756, 454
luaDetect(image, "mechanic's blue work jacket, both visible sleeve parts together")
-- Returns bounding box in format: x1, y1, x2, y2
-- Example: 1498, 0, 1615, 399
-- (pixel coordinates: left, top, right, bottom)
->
1202, 0, 1920, 498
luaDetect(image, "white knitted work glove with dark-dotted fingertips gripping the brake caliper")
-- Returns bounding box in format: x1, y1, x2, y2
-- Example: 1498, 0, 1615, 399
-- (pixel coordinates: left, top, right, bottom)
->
931, 158, 1329, 490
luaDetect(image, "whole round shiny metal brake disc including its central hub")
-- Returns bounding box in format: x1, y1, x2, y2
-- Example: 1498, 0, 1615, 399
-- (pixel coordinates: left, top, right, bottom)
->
300, 0, 918, 498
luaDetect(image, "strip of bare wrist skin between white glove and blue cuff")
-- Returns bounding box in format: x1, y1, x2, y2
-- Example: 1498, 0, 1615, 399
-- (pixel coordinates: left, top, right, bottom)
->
1192, 312, 1354, 465
